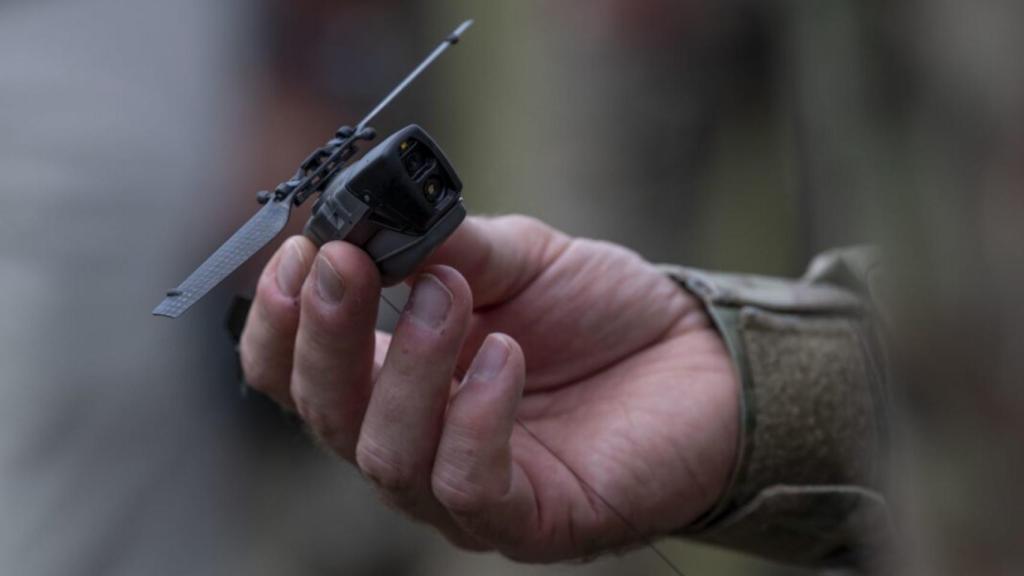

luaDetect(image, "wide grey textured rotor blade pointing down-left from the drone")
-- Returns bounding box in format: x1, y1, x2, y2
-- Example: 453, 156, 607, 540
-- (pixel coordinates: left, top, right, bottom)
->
153, 197, 292, 318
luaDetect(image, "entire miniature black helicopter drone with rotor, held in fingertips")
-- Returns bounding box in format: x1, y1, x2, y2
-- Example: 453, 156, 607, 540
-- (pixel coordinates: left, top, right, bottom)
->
153, 20, 473, 318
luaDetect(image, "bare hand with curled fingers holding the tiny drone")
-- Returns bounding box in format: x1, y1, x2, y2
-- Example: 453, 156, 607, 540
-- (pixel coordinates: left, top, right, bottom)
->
241, 216, 739, 562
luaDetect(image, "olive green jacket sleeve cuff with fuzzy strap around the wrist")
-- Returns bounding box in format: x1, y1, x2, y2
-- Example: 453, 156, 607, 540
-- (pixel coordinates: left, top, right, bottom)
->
664, 247, 888, 566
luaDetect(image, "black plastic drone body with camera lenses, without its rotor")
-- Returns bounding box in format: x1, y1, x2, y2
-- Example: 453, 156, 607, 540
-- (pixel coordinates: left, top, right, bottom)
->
304, 124, 466, 286
